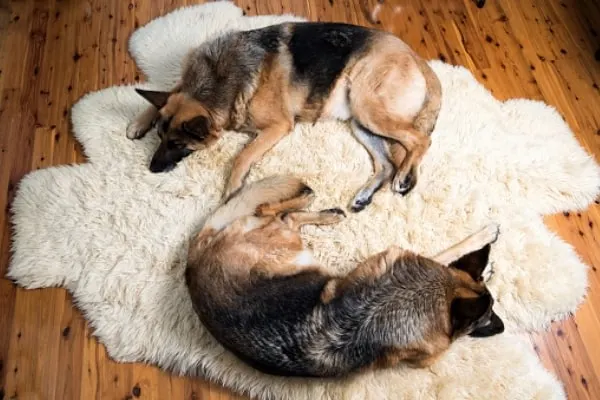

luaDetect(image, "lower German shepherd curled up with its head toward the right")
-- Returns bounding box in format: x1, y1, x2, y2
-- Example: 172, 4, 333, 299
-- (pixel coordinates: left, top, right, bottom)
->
185, 177, 504, 377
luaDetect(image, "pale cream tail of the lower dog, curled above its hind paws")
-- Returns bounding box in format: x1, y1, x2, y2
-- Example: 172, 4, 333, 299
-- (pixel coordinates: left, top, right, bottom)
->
202, 175, 312, 232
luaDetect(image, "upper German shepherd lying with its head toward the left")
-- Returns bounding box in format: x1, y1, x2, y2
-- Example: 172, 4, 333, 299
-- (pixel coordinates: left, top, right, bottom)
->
127, 23, 441, 211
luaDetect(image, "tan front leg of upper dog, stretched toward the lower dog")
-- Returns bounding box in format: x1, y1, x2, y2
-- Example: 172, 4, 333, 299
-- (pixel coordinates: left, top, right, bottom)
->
224, 124, 290, 199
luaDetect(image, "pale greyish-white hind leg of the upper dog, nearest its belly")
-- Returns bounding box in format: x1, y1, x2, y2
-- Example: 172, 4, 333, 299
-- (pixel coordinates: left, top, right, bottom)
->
350, 120, 401, 212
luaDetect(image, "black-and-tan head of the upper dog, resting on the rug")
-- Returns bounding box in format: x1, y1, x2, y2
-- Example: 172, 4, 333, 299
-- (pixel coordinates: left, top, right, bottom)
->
136, 89, 220, 172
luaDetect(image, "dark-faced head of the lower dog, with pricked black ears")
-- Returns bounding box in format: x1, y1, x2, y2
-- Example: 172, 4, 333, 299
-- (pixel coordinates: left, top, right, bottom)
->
449, 244, 504, 338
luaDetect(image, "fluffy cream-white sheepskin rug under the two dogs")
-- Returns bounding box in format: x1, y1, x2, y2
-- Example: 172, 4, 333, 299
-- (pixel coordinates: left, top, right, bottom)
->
8, 2, 600, 400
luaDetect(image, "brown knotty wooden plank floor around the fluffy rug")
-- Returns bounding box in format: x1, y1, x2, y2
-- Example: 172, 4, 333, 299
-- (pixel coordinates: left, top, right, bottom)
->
0, 0, 600, 400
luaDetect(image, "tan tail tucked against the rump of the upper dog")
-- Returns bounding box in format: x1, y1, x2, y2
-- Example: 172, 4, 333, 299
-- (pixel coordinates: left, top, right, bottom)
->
413, 57, 442, 135
